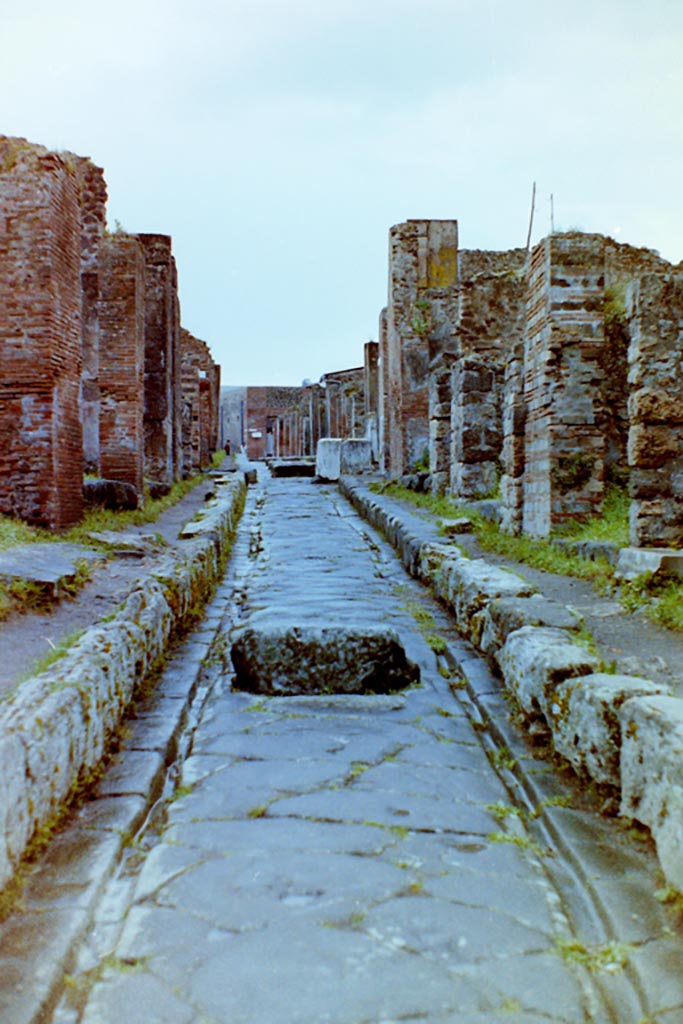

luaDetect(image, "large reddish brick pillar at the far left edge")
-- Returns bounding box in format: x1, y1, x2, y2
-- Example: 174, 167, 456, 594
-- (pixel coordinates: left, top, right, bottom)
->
0, 136, 83, 529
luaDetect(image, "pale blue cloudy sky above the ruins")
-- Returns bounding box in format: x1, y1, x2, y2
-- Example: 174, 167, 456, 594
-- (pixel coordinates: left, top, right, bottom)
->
0, 0, 683, 385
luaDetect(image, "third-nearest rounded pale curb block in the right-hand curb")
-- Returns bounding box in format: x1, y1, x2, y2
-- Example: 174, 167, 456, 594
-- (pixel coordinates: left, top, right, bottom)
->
498, 626, 599, 719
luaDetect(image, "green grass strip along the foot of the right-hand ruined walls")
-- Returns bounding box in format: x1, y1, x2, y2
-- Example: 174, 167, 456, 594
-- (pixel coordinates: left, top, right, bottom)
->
371, 481, 683, 632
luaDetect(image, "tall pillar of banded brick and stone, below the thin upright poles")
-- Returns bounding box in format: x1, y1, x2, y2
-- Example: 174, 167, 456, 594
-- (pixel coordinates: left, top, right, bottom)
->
523, 233, 605, 537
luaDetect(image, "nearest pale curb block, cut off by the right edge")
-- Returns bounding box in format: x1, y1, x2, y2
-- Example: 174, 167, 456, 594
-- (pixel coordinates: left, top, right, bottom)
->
620, 696, 683, 890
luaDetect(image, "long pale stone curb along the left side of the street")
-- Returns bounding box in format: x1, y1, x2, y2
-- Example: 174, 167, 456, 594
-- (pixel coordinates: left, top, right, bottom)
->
0, 476, 245, 888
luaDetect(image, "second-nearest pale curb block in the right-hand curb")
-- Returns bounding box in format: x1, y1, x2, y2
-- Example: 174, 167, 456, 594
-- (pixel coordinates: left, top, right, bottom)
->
549, 672, 671, 786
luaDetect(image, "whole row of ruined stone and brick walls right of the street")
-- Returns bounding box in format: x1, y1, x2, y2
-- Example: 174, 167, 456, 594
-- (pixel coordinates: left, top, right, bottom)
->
378, 221, 683, 546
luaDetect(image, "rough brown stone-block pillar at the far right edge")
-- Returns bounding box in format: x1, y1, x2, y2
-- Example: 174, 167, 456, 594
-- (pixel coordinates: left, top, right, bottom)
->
629, 273, 683, 547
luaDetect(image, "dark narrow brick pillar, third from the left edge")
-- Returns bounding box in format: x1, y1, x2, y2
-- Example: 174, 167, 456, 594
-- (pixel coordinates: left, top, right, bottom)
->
138, 234, 182, 486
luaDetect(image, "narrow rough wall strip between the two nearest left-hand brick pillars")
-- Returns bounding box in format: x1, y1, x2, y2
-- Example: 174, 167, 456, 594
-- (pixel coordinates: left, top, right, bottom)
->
73, 154, 106, 473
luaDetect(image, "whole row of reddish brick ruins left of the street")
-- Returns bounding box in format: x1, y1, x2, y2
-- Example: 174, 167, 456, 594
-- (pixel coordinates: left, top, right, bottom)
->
0, 136, 218, 530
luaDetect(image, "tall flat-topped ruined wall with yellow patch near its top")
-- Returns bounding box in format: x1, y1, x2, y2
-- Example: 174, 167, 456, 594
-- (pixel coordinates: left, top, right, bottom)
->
385, 220, 458, 475
